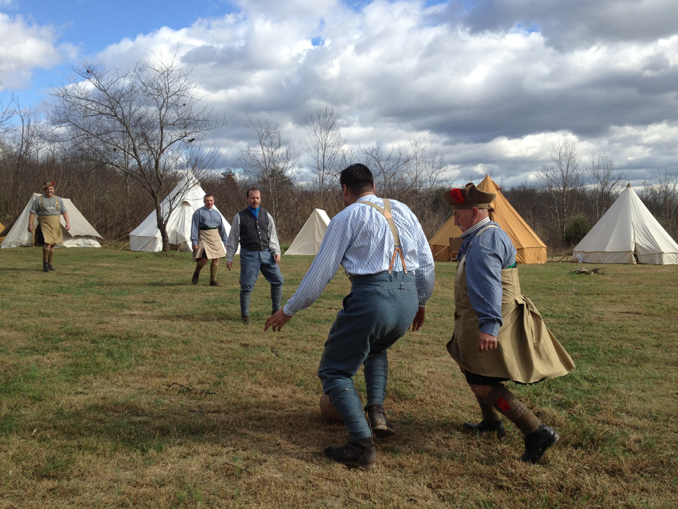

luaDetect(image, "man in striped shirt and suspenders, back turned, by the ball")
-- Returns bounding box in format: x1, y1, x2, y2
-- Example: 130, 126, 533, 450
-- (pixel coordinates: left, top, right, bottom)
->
264, 164, 435, 468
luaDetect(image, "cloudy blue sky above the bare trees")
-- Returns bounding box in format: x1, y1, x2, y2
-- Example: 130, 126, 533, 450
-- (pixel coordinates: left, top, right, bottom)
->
0, 0, 678, 187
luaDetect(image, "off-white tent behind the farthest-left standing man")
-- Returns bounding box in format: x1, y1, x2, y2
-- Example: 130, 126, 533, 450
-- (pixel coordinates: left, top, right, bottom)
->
0, 193, 103, 248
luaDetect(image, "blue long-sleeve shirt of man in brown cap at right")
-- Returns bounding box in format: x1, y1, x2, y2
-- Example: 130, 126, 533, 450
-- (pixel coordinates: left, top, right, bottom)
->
457, 221, 516, 337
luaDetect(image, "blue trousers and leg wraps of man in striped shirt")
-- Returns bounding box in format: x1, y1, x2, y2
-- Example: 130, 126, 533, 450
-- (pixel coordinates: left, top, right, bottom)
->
318, 271, 419, 440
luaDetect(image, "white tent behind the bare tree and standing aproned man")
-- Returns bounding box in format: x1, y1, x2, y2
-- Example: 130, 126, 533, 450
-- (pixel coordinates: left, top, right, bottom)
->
129, 176, 236, 252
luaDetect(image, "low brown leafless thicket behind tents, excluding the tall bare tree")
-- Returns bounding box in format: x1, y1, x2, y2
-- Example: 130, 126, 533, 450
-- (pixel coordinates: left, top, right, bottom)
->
0, 129, 678, 252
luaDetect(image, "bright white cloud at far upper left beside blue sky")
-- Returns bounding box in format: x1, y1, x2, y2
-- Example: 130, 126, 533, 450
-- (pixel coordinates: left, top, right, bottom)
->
0, 13, 61, 91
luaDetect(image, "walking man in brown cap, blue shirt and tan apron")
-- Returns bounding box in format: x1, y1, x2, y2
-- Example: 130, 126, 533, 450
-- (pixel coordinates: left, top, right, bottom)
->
444, 184, 574, 463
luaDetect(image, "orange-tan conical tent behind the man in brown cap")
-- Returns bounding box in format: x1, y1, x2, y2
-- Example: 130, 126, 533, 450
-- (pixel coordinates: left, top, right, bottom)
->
429, 175, 546, 263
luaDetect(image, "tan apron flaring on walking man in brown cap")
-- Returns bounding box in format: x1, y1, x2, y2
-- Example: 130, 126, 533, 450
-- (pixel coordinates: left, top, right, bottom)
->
447, 225, 574, 383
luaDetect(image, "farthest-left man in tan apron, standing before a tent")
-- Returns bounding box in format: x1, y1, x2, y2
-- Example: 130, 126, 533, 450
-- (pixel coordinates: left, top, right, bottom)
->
28, 181, 71, 272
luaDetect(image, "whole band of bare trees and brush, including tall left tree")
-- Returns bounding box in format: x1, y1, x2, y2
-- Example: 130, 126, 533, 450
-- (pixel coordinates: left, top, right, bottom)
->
0, 62, 678, 252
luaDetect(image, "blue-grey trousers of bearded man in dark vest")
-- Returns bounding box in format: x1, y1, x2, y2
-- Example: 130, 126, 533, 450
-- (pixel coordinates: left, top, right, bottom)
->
240, 248, 285, 316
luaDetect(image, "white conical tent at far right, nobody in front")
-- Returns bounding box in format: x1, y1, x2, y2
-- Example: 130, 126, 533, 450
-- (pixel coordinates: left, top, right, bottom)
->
572, 184, 678, 265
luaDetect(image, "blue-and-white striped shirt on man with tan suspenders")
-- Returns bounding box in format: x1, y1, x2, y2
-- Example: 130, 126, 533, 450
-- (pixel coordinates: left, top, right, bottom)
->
283, 195, 435, 316
